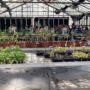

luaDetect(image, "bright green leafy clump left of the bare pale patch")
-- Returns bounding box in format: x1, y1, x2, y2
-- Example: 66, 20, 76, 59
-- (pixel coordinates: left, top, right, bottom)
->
0, 46, 26, 64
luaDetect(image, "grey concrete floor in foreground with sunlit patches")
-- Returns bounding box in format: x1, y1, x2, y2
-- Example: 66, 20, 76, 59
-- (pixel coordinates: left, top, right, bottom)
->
0, 66, 90, 90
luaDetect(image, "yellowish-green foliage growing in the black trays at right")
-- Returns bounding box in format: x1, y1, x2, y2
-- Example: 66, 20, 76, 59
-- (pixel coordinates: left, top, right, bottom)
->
48, 47, 90, 60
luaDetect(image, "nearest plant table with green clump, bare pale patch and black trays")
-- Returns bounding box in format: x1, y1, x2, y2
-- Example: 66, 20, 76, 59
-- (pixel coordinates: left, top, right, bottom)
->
0, 46, 90, 64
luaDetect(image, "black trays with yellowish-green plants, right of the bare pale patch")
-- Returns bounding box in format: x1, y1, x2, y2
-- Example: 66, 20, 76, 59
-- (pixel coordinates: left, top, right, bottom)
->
37, 47, 90, 62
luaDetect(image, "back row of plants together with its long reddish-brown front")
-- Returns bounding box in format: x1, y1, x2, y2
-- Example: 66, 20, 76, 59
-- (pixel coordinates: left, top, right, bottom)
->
0, 30, 85, 48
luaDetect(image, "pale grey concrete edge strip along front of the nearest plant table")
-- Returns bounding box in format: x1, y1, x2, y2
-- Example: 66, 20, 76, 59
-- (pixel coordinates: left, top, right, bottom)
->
0, 48, 90, 69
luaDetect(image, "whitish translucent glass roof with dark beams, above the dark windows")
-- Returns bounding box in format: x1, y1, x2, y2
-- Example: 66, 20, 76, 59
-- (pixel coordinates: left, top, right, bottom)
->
0, 0, 90, 17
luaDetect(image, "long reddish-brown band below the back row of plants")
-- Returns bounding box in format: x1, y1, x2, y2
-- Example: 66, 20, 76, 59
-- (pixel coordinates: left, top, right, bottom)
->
0, 41, 86, 48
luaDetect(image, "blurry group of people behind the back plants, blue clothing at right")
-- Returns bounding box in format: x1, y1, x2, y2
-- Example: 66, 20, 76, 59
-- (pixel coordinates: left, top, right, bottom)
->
34, 24, 89, 39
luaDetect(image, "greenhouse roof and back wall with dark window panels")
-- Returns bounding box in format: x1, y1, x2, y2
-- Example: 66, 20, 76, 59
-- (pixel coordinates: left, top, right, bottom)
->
0, 0, 90, 29
